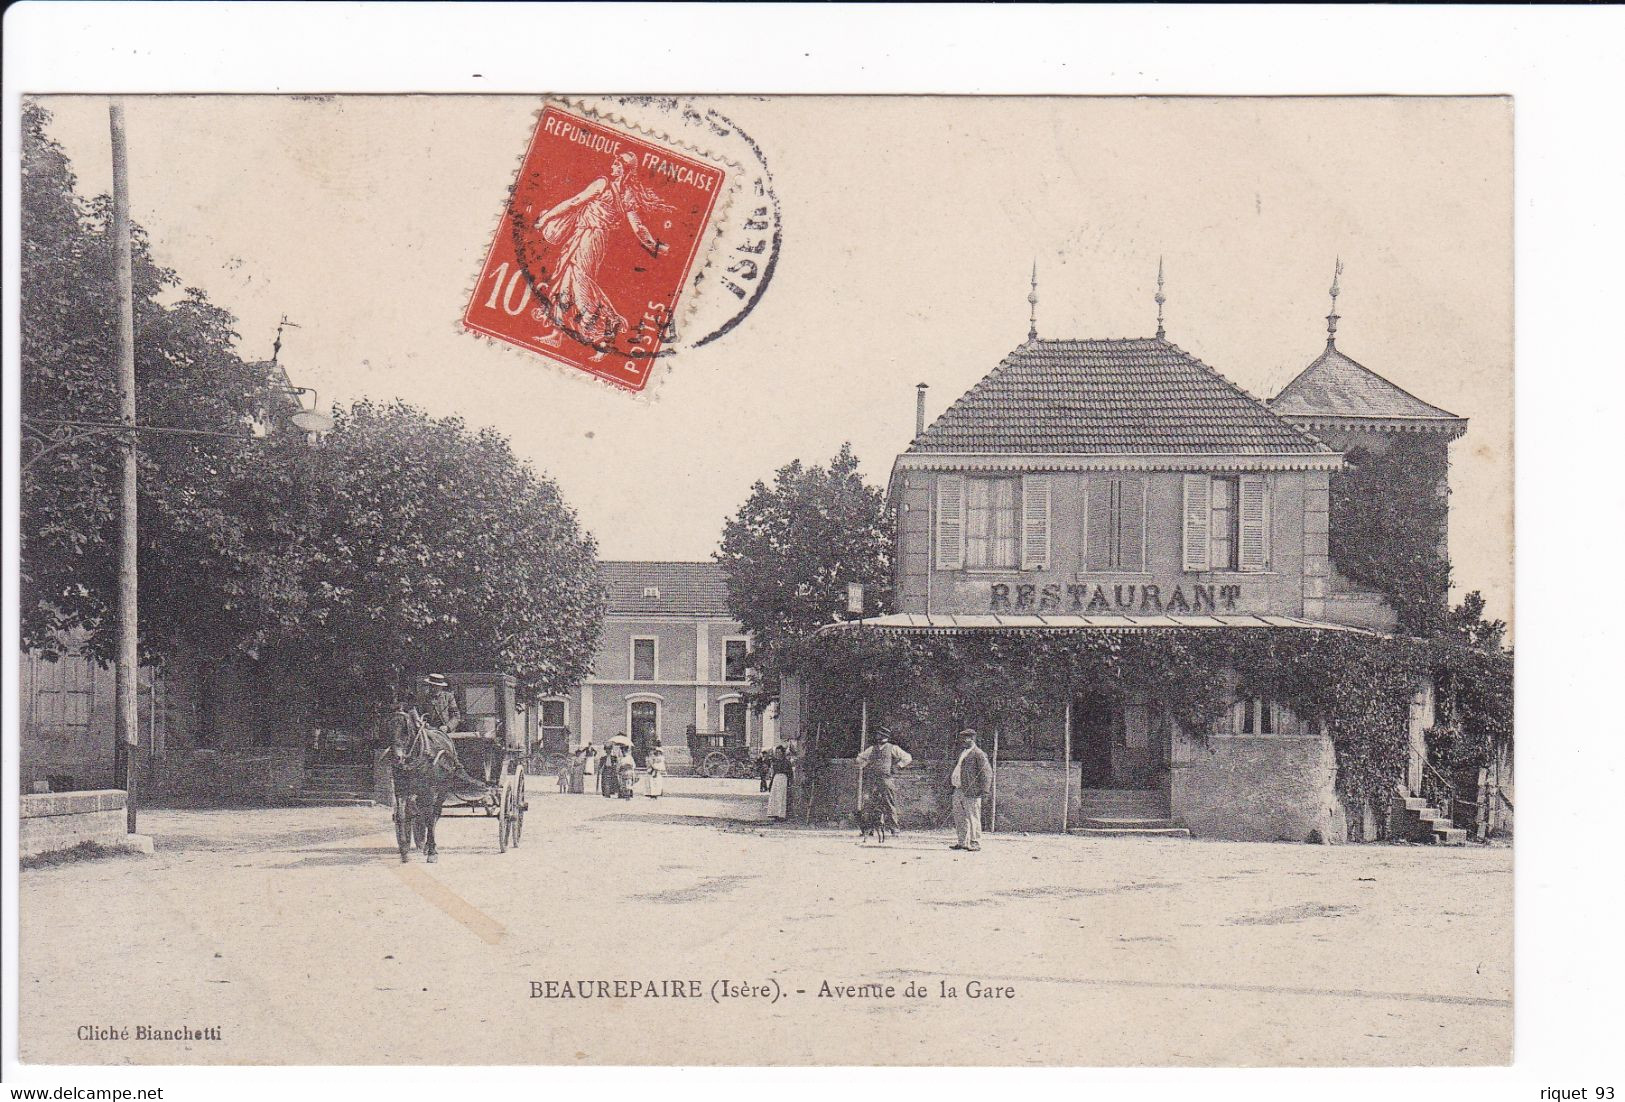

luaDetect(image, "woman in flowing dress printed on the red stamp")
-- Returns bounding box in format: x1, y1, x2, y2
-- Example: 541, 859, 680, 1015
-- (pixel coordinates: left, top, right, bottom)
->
536, 153, 673, 354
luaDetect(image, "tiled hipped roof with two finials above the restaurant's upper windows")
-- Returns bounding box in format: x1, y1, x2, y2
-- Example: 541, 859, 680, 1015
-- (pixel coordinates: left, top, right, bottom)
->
908, 338, 1331, 455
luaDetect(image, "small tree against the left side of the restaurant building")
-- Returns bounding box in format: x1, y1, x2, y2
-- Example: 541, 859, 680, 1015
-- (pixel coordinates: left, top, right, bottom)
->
715, 444, 892, 705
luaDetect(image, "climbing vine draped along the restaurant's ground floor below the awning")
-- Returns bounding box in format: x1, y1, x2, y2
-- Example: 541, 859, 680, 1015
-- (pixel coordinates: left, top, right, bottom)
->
798, 629, 1488, 825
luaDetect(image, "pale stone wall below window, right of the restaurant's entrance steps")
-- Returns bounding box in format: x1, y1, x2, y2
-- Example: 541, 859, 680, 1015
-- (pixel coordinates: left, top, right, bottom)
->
1170, 735, 1349, 842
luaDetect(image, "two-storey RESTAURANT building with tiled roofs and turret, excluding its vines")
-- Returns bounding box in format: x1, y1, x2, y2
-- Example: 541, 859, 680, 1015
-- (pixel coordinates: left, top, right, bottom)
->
780, 281, 1466, 840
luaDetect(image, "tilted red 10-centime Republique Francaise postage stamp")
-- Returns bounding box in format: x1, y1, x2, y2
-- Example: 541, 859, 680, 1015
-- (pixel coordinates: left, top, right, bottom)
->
463, 106, 726, 392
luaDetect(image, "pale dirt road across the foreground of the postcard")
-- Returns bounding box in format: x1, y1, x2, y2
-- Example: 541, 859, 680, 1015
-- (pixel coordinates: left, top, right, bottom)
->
20, 780, 1513, 1065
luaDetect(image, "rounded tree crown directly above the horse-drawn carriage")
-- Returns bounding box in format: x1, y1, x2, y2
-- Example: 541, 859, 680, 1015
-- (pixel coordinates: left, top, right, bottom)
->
262, 401, 605, 699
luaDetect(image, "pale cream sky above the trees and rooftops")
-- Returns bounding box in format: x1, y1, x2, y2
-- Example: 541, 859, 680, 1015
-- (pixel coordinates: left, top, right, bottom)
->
34, 96, 1513, 619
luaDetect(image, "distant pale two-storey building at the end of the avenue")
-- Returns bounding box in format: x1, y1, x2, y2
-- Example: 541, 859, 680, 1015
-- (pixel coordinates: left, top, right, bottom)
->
552, 561, 777, 772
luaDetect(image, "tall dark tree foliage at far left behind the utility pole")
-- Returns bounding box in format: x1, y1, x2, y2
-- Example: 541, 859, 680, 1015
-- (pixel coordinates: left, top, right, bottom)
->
20, 102, 265, 660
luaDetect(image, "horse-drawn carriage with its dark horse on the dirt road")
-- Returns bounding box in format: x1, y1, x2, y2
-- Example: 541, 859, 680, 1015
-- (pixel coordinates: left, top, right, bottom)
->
395, 673, 527, 861
